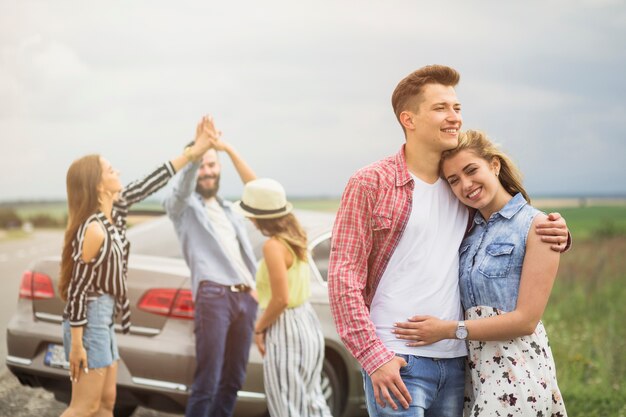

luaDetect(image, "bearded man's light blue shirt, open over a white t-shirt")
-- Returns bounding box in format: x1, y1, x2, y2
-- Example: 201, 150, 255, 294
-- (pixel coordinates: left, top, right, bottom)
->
164, 162, 257, 300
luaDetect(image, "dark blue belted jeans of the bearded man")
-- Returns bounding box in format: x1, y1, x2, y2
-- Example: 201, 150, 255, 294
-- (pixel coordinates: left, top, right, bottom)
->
185, 281, 258, 417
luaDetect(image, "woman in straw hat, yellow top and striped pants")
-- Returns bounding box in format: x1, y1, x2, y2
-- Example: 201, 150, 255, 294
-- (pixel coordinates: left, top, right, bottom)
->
235, 178, 331, 417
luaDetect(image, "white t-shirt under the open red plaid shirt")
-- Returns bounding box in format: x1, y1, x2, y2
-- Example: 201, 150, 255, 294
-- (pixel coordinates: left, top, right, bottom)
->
370, 174, 469, 358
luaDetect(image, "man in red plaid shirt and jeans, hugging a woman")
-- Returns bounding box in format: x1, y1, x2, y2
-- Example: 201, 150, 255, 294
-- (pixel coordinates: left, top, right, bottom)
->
328, 65, 568, 417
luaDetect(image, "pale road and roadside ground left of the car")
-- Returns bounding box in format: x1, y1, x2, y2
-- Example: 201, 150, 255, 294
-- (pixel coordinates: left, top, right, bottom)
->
0, 230, 182, 417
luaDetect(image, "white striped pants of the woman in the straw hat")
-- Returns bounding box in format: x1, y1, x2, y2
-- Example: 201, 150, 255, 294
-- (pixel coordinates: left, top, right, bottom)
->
263, 302, 332, 417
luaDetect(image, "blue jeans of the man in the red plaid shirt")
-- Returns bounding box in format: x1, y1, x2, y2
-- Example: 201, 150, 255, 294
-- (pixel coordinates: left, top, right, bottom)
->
363, 354, 465, 417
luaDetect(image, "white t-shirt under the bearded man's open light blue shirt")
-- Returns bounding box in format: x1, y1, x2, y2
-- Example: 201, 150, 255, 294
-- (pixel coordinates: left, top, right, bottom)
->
204, 197, 255, 288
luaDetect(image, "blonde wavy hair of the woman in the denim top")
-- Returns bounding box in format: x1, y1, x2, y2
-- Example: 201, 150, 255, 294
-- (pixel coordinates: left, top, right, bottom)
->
439, 130, 530, 203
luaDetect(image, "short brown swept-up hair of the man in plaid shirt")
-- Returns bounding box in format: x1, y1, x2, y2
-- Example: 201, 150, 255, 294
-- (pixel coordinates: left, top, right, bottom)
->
391, 65, 461, 129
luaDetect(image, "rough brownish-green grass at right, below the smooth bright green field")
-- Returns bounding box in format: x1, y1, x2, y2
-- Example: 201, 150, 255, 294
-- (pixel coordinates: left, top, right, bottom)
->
543, 236, 626, 417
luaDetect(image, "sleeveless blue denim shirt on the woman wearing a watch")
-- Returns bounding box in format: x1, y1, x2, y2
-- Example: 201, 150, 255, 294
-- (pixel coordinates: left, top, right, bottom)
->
459, 193, 539, 311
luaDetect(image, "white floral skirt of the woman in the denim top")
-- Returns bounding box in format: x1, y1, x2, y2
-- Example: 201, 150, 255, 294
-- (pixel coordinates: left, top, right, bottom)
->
464, 306, 567, 417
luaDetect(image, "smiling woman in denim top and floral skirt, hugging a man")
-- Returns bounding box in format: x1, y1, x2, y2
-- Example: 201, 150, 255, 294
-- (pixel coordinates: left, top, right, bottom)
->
394, 130, 566, 416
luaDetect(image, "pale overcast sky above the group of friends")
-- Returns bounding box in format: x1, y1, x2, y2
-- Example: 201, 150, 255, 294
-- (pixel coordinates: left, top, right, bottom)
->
0, 0, 626, 201
